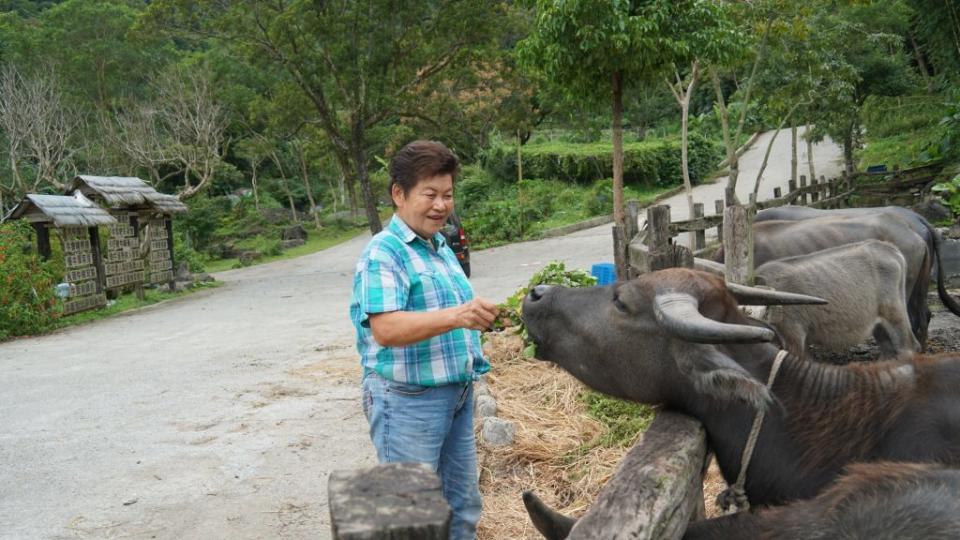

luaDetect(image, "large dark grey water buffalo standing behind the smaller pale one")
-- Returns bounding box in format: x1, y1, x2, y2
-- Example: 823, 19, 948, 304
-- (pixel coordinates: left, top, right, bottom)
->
736, 206, 960, 347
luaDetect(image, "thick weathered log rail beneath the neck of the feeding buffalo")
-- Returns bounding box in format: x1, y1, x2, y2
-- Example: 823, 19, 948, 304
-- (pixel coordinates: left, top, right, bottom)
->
567, 411, 707, 540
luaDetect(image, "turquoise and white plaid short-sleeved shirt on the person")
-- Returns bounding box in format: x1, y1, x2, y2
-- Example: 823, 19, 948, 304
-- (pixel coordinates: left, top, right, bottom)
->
350, 215, 490, 386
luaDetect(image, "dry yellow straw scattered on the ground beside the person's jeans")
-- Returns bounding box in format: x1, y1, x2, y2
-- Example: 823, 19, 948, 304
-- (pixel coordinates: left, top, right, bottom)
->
477, 332, 632, 540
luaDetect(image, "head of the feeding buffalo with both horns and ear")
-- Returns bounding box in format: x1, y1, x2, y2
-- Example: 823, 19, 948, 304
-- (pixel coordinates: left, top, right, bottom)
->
523, 268, 824, 408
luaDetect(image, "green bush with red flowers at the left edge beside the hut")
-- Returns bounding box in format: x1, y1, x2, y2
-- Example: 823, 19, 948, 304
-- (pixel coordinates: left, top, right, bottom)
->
0, 221, 59, 340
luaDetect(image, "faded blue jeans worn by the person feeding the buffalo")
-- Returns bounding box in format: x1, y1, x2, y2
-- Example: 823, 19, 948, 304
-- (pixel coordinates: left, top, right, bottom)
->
363, 373, 482, 540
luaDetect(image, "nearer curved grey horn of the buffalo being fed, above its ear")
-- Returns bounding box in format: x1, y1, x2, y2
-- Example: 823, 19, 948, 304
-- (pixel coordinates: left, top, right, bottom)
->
653, 292, 775, 343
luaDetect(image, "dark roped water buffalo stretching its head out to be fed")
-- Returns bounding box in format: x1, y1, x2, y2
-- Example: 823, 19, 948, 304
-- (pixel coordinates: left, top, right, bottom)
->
523, 268, 960, 505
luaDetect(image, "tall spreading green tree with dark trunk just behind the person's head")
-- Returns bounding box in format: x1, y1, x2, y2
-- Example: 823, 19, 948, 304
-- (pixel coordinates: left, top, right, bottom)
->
142, 0, 508, 232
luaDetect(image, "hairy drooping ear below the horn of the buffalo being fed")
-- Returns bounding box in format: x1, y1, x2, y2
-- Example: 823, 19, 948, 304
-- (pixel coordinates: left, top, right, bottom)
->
673, 343, 773, 411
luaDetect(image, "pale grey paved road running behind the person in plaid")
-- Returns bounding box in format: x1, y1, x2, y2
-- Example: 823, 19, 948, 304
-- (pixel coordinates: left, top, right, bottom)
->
0, 127, 829, 539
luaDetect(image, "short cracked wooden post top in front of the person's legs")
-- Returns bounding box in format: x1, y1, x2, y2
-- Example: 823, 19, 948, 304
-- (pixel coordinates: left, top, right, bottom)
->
327, 463, 450, 540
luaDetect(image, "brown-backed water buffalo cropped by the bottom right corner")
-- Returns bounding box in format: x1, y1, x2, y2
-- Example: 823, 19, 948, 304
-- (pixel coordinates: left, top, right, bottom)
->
523, 462, 960, 540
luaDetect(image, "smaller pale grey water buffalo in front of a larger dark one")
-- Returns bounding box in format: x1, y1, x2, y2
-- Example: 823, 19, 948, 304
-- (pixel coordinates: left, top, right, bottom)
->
756, 240, 920, 357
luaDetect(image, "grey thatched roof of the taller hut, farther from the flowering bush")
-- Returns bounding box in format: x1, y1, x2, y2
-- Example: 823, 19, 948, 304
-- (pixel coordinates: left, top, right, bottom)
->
68, 174, 187, 214
